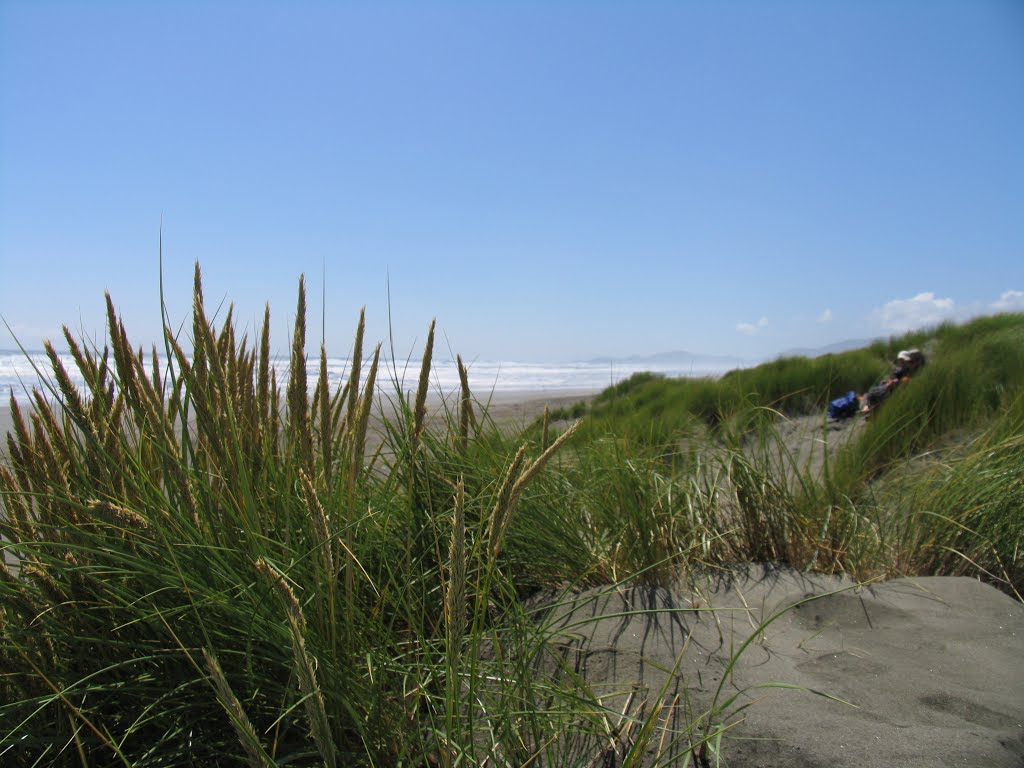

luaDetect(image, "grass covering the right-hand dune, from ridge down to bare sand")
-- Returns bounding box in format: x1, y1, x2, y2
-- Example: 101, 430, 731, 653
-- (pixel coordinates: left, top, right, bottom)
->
534, 314, 1024, 592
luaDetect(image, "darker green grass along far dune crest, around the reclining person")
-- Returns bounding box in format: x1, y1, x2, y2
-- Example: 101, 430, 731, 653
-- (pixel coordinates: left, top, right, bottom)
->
569, 314, 1024, 443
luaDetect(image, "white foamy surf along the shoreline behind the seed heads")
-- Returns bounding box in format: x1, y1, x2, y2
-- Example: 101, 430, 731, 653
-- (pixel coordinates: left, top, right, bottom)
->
0, 351, 737, 406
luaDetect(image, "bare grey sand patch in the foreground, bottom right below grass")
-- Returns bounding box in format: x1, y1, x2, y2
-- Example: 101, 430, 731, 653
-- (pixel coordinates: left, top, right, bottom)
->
547, 568, 1024, 768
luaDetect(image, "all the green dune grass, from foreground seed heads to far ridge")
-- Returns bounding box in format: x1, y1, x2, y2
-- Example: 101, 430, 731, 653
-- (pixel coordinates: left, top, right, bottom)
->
0, 268, 1024, 767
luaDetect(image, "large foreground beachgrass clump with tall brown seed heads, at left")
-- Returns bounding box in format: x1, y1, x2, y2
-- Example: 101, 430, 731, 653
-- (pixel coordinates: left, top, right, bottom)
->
0, 266, 638, 766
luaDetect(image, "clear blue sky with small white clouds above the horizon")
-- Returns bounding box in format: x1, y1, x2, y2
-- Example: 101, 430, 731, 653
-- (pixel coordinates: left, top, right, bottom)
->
0, 0, 1024, 360
